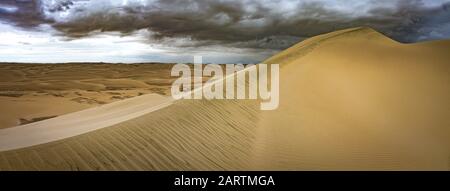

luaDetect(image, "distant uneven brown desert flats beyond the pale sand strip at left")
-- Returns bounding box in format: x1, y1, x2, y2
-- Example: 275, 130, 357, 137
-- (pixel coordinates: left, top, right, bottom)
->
0, 63, 182, 129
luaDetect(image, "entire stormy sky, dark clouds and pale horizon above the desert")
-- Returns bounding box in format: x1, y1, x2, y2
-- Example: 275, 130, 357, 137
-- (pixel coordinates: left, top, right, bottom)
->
0, 0, 450, 63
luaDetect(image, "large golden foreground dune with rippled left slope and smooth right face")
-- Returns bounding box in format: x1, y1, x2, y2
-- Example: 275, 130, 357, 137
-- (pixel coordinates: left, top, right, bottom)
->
0, 28, 450, 170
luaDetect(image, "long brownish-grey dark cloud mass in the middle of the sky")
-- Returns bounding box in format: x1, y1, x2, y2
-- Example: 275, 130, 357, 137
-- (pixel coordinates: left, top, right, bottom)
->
54, 0, 350, 48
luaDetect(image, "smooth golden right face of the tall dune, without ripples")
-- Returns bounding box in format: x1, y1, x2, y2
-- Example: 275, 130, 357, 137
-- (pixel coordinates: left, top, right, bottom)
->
256, 28, 450, 170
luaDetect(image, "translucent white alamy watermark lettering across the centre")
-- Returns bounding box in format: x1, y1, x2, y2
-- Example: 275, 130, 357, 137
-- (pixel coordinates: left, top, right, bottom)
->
171, 56, 280, 110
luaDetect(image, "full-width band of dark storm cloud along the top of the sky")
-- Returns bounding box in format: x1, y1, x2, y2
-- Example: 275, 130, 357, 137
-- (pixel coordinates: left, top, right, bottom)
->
0, 0, 450, 49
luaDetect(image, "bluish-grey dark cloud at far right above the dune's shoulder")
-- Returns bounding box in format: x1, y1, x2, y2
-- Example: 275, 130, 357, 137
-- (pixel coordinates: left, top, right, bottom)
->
362, 0, 450, 42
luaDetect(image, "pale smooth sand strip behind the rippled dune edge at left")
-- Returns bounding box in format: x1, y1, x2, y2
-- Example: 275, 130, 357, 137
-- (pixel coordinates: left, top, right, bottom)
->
0, 94, 172, 151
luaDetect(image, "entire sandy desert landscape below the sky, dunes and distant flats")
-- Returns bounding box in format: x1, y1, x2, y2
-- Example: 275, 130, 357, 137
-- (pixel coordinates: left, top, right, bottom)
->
0, 27, 450, 170
